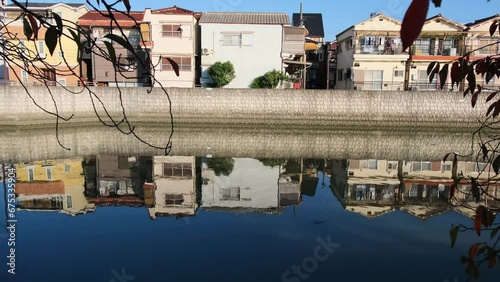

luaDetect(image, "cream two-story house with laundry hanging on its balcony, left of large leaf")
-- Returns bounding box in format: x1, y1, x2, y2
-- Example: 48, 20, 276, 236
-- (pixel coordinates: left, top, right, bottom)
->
336, 14, 408, 90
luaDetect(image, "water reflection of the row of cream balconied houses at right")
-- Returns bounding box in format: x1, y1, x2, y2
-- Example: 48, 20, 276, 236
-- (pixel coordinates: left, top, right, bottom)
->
332, 160, 500, 219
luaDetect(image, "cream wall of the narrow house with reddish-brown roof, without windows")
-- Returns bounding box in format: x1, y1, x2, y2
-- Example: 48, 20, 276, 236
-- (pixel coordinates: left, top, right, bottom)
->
144, 9, 197, 88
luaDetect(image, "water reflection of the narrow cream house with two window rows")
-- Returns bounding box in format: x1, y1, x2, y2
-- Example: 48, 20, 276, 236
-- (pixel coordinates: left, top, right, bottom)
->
145, 156, 198, 219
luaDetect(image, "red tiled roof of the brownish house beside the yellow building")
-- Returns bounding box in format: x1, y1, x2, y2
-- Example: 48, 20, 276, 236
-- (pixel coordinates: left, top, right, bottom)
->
78, 11, 144, 27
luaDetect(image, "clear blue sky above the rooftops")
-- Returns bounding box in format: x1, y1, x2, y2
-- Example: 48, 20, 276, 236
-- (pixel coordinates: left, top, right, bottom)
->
21, 0, 500, 40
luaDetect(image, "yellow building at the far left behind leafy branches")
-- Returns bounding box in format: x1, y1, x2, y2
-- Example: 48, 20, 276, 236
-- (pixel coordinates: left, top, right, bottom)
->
2, 2, 88, 86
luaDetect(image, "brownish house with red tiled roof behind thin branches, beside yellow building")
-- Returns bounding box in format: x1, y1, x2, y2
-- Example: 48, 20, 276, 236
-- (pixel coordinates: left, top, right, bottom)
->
78, 11, 146, 87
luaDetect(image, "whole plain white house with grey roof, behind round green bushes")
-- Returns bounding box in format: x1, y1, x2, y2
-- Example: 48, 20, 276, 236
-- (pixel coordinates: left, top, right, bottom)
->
199, 12, 290, 88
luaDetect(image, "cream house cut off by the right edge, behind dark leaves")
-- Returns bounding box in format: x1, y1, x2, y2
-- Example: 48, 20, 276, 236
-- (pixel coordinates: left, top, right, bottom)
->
466, 14, 500, 90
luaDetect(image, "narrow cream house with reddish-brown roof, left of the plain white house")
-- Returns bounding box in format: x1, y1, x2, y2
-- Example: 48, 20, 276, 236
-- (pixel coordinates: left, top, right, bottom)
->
141, 6, 201, 88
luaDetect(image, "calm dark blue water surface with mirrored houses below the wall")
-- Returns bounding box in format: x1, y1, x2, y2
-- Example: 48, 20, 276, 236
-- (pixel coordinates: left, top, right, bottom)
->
0, 126, 500, 282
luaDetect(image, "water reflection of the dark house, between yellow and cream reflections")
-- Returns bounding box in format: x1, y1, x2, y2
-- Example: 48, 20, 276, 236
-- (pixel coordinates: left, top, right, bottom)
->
85, 155, 152, 206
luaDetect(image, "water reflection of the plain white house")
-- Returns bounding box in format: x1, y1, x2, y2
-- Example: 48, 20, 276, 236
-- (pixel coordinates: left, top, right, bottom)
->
202, 158, 284, 213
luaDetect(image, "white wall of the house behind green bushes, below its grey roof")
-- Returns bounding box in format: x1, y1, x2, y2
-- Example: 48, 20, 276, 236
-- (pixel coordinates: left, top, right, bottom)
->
200, 23, 283, 88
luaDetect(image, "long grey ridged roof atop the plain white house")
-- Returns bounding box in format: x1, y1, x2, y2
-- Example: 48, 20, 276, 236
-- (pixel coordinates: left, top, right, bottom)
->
200, 12, 290, 25
